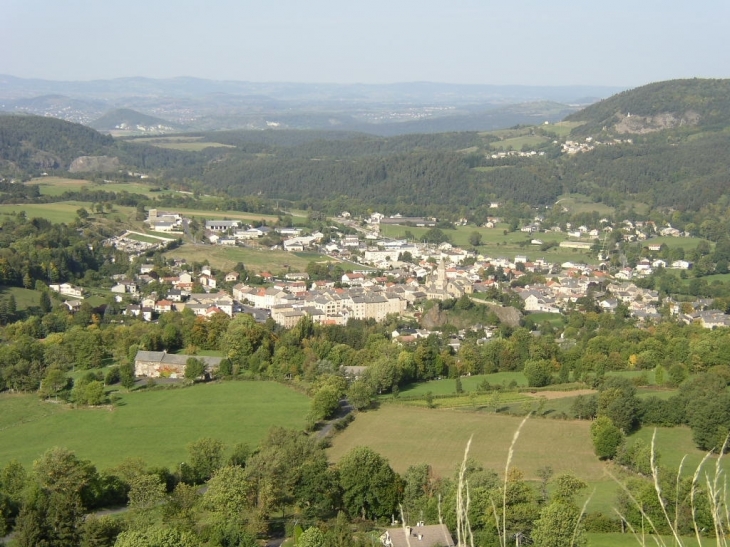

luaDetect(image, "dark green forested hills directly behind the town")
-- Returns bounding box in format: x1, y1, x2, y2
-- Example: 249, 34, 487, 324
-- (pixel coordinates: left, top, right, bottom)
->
0, 80, 730, 218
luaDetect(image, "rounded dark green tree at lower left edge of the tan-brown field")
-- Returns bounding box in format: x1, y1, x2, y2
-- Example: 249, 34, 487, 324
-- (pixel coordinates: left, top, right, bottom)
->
339, 446, 400, 519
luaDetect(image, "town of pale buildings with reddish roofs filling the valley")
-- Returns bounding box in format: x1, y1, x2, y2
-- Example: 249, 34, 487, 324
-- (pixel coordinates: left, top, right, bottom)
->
84, 208, 730, 335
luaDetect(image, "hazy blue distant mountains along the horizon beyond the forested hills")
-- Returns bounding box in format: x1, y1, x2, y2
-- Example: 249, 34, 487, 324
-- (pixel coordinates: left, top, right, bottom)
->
0, 75, 621, 136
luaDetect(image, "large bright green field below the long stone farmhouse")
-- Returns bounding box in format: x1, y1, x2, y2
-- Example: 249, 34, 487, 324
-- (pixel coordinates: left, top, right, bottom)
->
0, 382, 309, 469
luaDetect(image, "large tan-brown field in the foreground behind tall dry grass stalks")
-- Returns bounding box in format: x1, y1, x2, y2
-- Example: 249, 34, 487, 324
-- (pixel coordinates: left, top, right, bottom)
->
330, 405, 604, 482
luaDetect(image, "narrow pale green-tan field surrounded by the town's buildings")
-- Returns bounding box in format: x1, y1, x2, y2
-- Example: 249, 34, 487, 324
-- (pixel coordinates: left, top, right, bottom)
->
165, 244, 336, 274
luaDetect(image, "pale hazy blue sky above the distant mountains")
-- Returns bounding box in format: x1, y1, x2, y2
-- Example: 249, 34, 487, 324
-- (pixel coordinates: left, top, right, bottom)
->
0, 0, 730, 87
